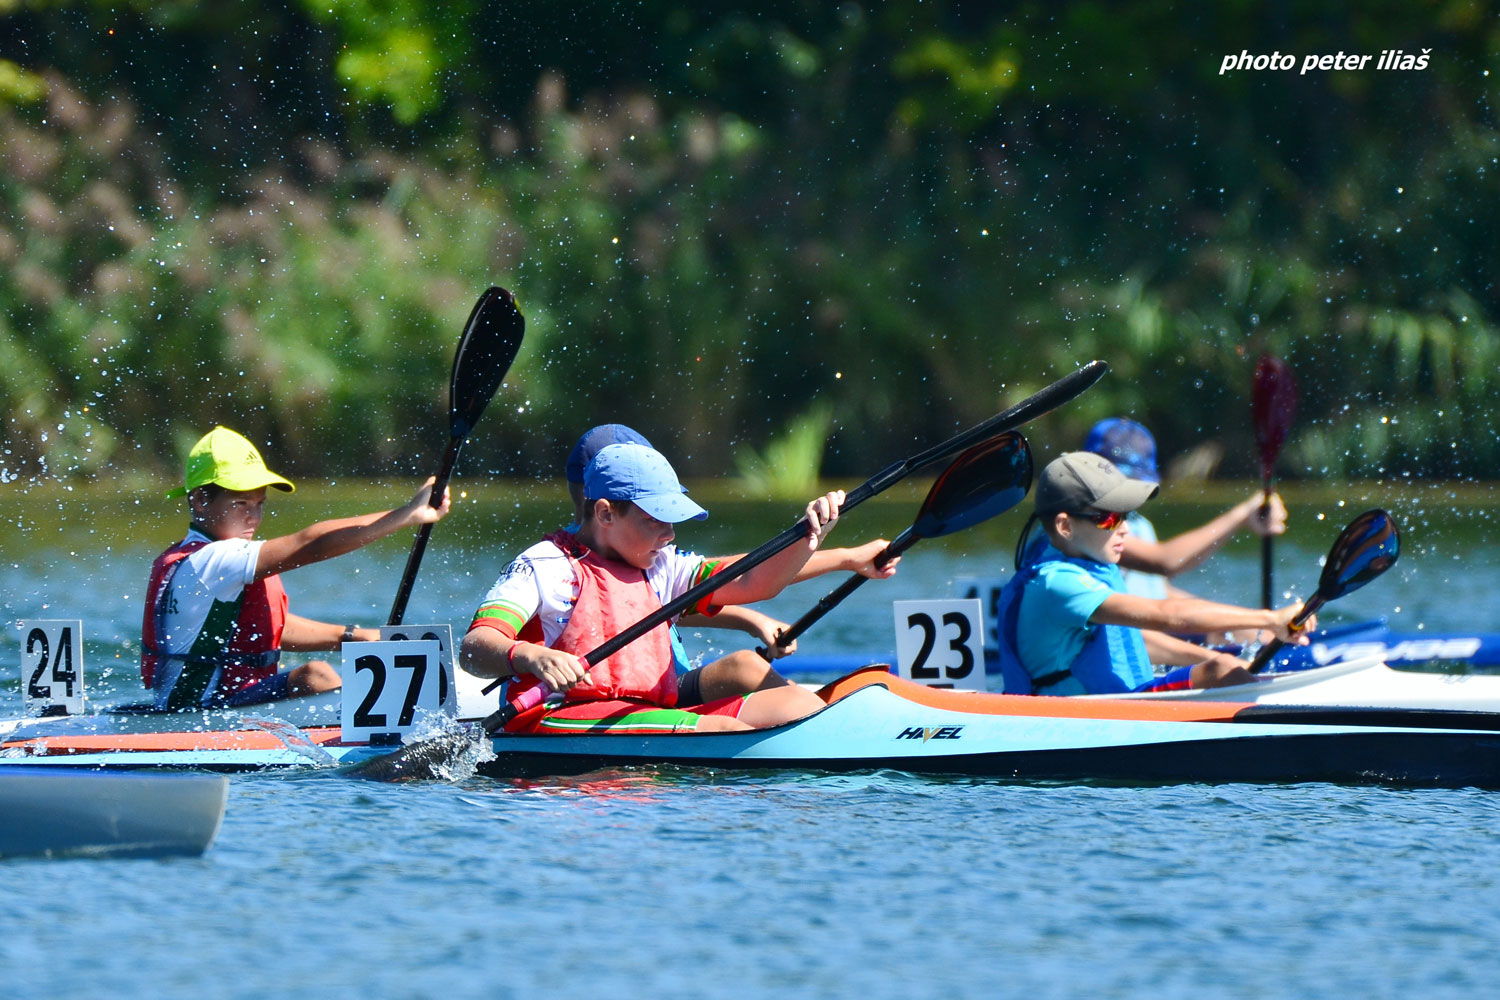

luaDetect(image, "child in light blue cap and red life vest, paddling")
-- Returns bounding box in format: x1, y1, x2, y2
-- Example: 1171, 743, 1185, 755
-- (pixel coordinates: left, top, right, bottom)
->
461, 444, 843, 733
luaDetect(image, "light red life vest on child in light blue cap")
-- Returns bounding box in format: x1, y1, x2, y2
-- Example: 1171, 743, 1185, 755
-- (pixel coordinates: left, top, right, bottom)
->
510, 534, 677, 708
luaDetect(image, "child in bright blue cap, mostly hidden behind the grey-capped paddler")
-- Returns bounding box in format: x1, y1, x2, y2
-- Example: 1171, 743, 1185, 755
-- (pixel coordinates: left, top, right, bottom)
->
1083, 417, 1287, 598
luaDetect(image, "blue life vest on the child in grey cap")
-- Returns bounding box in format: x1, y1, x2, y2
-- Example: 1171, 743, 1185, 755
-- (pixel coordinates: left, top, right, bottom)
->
996, 544, 1155, 694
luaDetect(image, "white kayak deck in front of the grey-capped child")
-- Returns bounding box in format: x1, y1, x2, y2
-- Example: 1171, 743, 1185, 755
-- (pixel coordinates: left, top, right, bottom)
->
1104, 654, 1500, 712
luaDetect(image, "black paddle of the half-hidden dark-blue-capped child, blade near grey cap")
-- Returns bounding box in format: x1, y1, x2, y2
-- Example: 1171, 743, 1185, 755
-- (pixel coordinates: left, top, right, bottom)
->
756, 430, 1032, 661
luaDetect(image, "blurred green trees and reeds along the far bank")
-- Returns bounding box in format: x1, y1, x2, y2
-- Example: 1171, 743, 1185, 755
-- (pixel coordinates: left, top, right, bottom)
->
0, 0, 1500, 481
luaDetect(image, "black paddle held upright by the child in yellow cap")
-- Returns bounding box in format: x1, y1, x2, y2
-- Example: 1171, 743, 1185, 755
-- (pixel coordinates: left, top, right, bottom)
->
386, 288, 527, 625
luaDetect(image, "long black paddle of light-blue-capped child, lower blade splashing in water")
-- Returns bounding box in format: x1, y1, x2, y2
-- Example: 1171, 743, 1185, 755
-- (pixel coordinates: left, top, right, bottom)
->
345, 361, 1110, 781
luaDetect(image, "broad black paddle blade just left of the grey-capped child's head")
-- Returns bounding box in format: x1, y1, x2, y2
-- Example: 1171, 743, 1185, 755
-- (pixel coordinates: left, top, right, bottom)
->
912, 430, 1032, 538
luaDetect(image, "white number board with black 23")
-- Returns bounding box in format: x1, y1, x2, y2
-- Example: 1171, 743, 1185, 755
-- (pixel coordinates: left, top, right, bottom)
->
891, 598, 986, 691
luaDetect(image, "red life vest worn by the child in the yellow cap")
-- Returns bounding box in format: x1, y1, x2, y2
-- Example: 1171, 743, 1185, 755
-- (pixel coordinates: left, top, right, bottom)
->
141, 541, 288, 697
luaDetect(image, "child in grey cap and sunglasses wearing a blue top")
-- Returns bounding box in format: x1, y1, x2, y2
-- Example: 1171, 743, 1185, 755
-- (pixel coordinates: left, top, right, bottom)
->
998, 451, 1317, 694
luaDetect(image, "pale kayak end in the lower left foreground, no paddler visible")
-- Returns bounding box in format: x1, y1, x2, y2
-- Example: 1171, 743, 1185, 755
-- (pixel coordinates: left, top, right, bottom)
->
0, 765, 230, 858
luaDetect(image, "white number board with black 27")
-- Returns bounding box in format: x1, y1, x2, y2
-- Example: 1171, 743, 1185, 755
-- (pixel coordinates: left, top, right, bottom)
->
341, 625, 456, 744
